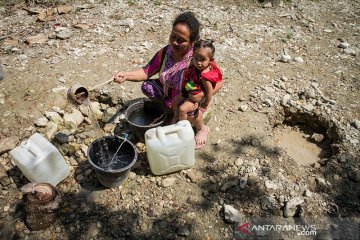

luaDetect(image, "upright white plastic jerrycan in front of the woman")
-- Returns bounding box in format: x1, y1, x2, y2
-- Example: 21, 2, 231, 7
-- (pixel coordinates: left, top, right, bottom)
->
145, 120, 195, 175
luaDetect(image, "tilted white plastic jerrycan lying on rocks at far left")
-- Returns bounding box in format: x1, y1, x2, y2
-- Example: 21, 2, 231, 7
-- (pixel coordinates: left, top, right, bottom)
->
10, 133, 70, 186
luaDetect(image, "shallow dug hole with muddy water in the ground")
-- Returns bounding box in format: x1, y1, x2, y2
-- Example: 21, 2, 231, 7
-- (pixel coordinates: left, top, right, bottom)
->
274, 109, 339, 166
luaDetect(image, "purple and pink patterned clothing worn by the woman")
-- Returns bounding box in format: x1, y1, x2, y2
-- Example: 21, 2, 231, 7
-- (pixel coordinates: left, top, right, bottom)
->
141, 45, 193, 108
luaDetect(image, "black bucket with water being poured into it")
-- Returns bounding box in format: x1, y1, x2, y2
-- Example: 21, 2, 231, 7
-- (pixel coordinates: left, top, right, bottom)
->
88, 136, 137, 188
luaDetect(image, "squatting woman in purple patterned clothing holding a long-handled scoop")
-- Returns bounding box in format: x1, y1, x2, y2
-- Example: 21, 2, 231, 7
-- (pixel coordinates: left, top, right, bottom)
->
114, 12, 222, 149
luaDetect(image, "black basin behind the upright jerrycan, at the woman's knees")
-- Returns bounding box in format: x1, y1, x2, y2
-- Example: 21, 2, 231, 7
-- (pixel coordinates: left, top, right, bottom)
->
125, 100, 167, 142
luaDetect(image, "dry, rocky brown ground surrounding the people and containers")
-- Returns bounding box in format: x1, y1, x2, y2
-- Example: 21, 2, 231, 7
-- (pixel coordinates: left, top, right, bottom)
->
0, 0, 360, 239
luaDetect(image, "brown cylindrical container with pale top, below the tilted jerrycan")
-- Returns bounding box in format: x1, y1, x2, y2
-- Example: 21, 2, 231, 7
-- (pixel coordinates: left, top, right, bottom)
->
23, 183, 61, 231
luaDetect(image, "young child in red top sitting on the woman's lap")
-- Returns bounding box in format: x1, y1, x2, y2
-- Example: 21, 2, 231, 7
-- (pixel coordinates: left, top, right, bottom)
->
172, 40, 222, 123
